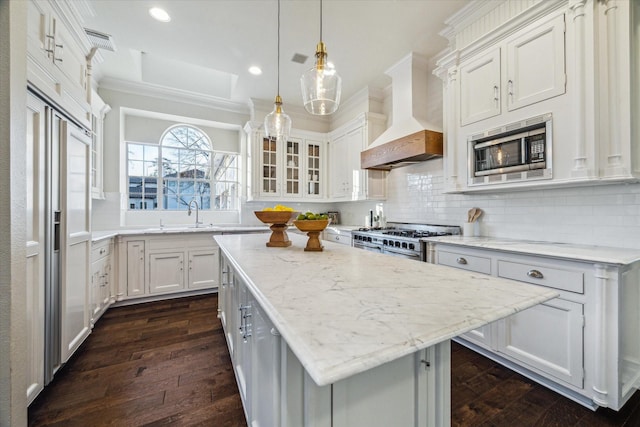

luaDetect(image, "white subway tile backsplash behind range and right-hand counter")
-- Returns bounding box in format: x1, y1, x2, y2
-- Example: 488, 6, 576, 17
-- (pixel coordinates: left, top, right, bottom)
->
384, 160, 640, 249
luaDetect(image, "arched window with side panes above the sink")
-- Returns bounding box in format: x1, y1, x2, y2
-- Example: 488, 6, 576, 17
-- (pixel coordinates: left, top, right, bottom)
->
127, 124, 238, 210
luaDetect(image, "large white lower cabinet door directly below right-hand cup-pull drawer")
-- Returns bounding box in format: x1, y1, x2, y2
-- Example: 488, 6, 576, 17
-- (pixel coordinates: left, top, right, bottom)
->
497, 298, 584, 388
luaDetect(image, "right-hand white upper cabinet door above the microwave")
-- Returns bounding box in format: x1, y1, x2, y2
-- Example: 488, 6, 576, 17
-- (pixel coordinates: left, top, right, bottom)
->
506, 15, 566, 111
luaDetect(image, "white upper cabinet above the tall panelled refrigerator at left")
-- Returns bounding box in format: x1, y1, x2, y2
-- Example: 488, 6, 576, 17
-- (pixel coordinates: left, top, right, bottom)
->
27, 0, 91, 128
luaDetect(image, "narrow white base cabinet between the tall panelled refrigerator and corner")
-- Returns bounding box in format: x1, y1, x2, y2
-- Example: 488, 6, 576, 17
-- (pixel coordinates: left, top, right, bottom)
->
91, 239, 113, 327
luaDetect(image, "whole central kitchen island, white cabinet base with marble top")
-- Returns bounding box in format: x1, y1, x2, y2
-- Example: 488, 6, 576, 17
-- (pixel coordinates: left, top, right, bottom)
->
214, 235, 558, 427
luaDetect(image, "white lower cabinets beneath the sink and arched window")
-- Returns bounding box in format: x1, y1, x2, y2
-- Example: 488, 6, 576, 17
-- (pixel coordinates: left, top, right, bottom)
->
116, 232, 219, 301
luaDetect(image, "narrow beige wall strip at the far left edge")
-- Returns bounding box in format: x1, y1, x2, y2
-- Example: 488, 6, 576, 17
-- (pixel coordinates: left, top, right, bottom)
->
0, 1, 28, 427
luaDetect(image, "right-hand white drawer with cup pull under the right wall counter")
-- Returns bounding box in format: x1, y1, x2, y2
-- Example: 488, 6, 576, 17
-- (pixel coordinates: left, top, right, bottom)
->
498, 260, 584, 294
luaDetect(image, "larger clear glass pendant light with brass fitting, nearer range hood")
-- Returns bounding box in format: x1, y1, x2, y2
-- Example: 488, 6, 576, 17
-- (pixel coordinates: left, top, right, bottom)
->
300, 0, 342, 116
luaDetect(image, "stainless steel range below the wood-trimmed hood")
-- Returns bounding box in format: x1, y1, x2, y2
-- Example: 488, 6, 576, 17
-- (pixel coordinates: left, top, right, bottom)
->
351, 222, 460, 261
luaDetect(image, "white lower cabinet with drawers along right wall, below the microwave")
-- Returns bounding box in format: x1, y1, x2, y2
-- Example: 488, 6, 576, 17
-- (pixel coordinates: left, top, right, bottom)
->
428, 242, 640, 410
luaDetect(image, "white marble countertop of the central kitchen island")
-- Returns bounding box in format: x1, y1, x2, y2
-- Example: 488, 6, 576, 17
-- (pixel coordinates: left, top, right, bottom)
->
214, 233, 558, 386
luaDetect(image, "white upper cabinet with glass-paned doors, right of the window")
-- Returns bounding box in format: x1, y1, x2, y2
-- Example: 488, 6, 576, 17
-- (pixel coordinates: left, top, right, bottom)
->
245, 123, 326, 201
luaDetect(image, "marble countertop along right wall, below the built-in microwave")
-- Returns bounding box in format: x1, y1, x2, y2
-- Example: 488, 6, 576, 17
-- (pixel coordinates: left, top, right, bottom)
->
421, 236, 640, 265
